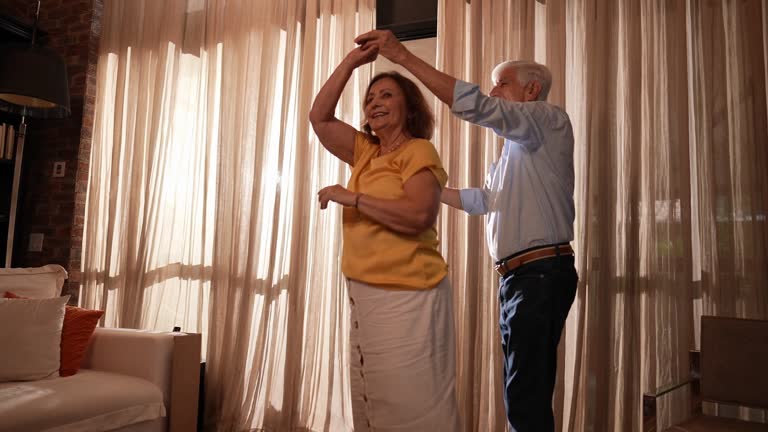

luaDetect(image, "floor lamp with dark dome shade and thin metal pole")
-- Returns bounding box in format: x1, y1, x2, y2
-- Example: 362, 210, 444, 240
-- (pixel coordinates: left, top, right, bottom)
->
0, 1, 70, 267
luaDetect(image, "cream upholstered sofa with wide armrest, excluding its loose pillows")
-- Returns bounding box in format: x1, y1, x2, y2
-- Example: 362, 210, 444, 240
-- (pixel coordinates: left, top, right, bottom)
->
0, 266, 201, 432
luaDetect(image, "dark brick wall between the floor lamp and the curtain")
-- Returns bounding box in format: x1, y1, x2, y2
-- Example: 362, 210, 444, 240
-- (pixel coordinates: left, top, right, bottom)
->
0, 0, 103, 303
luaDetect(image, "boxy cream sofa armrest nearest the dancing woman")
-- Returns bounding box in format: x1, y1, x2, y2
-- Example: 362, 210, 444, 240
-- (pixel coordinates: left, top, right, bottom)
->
82, 328, 201, 432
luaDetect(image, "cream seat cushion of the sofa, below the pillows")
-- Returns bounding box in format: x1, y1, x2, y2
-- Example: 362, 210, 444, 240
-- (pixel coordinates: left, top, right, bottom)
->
0, 369, 165, 432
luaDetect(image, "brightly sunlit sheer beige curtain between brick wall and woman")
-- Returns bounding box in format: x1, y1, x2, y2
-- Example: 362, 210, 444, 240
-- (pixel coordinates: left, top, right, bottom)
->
81, 0, 374, 431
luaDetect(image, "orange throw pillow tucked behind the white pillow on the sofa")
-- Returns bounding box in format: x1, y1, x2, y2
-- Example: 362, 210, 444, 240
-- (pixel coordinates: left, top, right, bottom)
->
5, 292, 104, 376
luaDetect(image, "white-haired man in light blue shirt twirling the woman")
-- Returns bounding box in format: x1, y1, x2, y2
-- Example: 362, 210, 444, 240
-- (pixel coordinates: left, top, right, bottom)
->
355, 30, 578, 432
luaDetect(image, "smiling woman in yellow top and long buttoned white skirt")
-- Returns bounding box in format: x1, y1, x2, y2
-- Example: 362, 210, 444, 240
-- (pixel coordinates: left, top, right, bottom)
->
310, 46, 459, 432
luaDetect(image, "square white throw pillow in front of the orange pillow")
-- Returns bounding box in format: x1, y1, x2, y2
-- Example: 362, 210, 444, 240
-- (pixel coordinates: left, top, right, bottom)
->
0, 296, 69, 382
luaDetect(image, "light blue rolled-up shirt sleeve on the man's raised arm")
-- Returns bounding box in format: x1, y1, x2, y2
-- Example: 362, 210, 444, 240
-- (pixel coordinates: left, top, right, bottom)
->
451, 80, 559, 151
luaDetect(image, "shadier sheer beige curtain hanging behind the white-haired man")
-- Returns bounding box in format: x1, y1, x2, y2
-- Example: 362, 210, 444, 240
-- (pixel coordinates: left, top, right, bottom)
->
436, 0, 768, 432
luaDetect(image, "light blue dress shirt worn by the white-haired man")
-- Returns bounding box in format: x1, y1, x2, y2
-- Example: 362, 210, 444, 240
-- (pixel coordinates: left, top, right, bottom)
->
451, 80, 575, 261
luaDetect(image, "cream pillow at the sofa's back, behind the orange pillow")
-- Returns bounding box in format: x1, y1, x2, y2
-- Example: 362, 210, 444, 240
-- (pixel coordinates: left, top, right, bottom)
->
0, 264, 67, 298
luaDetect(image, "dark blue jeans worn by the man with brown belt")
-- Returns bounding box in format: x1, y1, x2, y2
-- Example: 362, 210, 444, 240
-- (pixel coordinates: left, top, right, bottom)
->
499, 255, 579, 432
